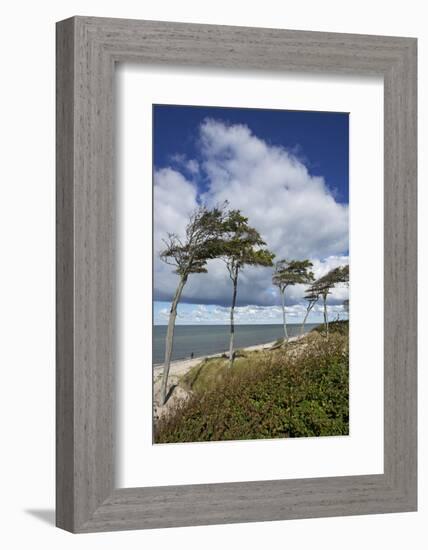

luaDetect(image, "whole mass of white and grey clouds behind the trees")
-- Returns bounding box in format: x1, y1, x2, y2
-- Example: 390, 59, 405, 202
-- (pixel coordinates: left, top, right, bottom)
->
154, 119, 348, 314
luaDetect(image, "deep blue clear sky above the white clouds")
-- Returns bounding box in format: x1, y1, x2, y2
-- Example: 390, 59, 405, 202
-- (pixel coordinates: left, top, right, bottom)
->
153, 105, 349, 203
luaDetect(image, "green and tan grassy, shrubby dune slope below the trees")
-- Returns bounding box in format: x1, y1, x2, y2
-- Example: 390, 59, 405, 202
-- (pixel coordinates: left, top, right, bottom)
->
155, 323, 349, 443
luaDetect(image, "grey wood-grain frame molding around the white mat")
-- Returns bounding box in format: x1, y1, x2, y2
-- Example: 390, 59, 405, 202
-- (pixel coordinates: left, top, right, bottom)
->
56, 17, 417, 533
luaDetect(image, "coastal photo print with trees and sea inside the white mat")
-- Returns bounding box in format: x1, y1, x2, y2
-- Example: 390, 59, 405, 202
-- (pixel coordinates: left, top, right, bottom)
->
150, 105, 349, 443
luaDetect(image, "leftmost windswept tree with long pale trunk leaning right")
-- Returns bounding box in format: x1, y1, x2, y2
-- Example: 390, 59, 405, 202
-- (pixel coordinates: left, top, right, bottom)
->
160, 203, 226, 405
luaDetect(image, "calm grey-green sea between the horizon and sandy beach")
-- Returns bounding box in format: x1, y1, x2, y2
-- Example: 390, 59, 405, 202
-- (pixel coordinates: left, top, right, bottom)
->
153, 323, 318, 365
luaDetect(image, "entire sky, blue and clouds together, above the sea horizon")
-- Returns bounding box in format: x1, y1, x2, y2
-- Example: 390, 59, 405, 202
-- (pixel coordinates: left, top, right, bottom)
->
153, 105, 349, 324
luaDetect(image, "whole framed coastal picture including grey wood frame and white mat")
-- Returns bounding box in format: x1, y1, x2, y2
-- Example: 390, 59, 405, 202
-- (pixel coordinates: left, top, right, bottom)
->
57, 17, 417, 533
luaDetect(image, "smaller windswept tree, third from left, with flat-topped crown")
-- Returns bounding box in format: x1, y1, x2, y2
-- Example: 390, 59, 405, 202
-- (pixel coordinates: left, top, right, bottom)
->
272, 260, 314, 342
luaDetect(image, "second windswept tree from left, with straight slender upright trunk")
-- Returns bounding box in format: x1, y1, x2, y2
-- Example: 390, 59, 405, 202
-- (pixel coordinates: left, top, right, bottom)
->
221, 210, 275, 367
